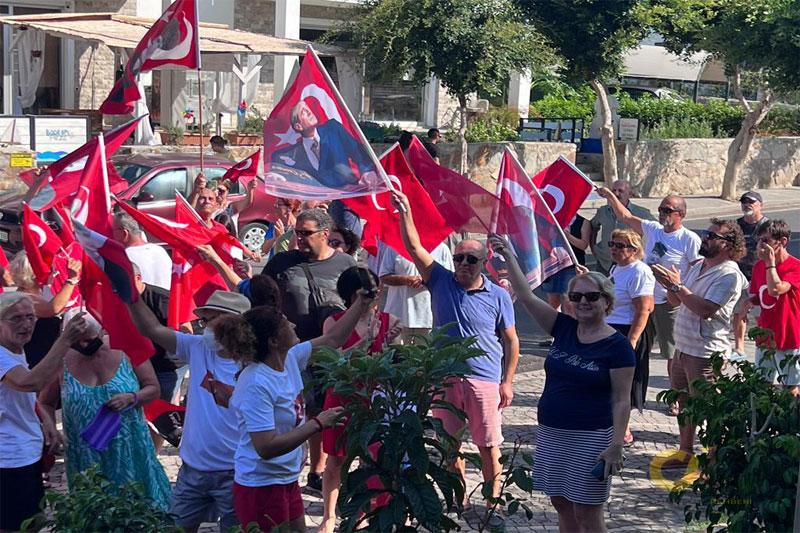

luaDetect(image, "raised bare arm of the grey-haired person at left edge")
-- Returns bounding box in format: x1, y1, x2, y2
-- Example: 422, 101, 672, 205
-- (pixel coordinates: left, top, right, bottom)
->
3, 313, 87, 392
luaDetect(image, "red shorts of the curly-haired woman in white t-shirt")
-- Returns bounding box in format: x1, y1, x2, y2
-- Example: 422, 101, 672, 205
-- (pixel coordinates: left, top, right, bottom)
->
233, 481, 305, 531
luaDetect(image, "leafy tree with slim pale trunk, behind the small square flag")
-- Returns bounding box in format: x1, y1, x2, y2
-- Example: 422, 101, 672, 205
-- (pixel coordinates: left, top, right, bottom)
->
517, 0, 647, 184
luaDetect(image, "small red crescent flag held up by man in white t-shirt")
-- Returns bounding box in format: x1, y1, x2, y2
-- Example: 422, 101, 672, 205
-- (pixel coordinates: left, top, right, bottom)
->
531, 156, 594, 228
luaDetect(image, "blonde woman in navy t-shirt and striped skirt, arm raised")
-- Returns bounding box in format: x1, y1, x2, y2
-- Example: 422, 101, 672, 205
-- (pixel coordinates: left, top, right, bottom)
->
489, 235, 636, 531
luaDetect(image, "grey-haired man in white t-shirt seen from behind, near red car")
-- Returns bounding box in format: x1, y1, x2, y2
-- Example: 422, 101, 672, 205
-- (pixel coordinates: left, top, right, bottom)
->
111, 211, 172, 291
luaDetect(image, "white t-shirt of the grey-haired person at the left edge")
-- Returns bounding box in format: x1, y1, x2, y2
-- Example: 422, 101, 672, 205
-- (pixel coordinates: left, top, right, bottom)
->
0, 346, 44, 468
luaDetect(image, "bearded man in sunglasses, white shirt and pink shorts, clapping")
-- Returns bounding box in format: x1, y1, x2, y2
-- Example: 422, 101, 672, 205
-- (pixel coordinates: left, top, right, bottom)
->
653, 218, 747, 467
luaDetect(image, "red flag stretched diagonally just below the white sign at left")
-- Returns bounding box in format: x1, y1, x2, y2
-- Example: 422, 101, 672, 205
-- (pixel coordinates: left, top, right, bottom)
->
30, 117, 143, 212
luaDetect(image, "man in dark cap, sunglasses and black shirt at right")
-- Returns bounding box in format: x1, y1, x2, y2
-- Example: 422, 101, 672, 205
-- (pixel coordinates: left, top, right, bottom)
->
731, 191, 769, 361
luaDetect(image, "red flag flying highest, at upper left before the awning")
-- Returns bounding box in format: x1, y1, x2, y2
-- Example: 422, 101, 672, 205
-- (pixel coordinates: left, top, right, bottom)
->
100, 0, 200, 115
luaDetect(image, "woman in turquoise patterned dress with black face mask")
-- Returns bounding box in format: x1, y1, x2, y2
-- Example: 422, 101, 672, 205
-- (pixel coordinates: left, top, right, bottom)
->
40, 317, 170, 511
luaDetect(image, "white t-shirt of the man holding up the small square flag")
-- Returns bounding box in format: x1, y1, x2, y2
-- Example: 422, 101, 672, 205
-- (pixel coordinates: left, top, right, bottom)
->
642, 220, 700, 304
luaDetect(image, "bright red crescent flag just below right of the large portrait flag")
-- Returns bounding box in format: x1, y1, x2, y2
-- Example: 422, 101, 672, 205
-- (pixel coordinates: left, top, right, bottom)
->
342, 144, 453, 261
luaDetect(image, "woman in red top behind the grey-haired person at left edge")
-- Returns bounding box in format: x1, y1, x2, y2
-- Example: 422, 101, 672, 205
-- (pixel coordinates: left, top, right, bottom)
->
8, 252, 81, 367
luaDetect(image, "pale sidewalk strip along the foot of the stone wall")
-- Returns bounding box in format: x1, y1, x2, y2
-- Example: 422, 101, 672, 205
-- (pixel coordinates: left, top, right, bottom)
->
580, 187, 800, 220
